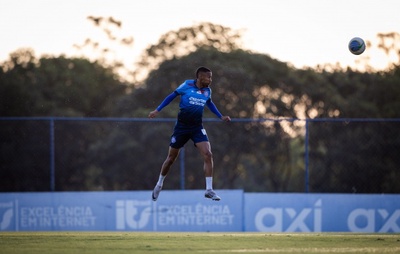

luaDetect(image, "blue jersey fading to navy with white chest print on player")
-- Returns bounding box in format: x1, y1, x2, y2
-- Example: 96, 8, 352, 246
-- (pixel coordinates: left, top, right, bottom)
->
175, 80, 211, 125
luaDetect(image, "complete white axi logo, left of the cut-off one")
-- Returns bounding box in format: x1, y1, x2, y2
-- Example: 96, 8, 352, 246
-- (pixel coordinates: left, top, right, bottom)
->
254, 199, 322, 232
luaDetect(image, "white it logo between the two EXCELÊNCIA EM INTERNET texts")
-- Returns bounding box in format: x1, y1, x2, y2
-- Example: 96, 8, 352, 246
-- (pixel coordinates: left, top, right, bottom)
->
116, 200, 151, 230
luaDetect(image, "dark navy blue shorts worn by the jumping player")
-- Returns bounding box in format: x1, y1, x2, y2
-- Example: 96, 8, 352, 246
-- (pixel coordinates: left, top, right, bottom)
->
169, 123, 208, 149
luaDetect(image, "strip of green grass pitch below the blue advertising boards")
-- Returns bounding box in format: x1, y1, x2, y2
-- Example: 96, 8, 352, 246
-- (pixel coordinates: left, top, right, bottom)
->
0, 232, 400, 254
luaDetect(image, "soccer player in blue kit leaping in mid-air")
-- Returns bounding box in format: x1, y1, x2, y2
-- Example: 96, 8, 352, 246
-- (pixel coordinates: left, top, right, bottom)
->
149, 67, 231, 201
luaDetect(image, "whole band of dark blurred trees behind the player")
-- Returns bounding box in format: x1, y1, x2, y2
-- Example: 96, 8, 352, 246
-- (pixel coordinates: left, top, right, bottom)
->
0, 23, 400, 193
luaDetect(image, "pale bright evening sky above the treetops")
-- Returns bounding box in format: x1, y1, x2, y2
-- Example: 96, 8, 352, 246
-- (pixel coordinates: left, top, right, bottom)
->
0, 0, 400, 76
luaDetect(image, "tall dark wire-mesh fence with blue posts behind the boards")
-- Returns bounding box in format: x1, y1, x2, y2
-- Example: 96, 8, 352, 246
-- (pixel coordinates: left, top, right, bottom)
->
0, 117, 400, 193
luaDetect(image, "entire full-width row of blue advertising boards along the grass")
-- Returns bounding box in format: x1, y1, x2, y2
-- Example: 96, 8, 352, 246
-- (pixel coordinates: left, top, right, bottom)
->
0, 190, 400, 233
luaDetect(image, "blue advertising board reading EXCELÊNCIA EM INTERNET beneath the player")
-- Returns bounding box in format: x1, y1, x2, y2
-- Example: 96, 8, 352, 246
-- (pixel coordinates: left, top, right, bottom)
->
0, 190, 243, 232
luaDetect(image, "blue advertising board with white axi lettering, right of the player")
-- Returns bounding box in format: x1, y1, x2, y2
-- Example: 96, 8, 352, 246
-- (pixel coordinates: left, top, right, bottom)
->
244, 193, 400, 233
